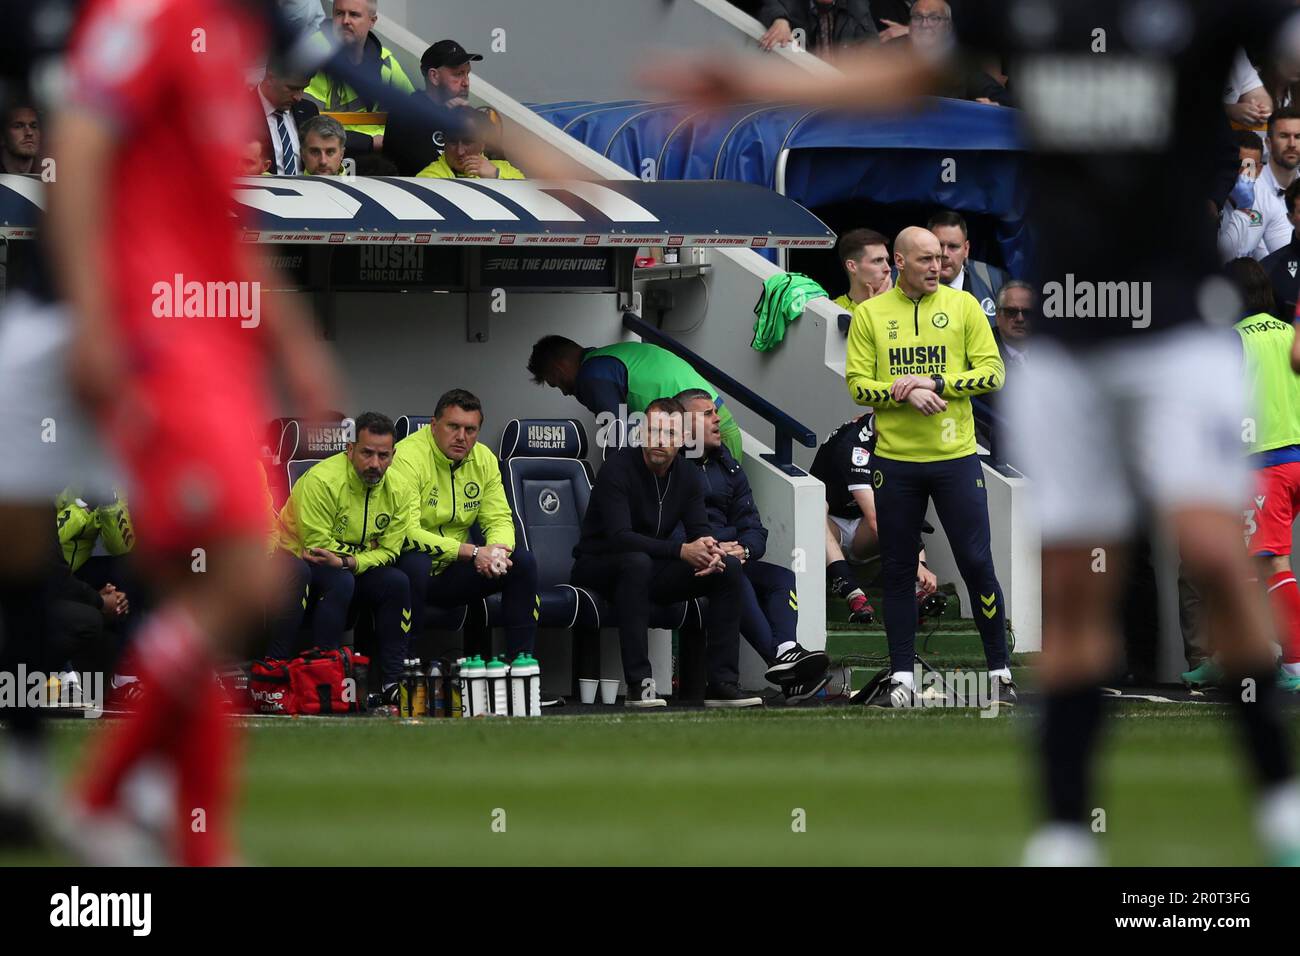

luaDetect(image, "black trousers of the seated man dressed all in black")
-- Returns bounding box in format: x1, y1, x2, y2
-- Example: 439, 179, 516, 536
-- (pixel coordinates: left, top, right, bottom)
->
569, 551, 745, 692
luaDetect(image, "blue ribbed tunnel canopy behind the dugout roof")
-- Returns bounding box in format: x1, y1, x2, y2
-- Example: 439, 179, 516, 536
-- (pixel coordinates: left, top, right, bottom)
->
532, 99, 1028, 274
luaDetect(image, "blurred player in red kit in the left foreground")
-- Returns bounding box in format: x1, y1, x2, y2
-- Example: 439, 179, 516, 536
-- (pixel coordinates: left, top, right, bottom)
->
49, 0, 337, 865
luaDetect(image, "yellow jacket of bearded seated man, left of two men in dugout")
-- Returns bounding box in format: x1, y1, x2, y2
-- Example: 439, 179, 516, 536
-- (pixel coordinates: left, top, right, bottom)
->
280, 451, 415, 574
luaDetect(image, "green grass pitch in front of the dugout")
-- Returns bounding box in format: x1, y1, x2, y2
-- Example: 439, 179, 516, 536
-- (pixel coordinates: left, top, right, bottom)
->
0, 704, 1289, 866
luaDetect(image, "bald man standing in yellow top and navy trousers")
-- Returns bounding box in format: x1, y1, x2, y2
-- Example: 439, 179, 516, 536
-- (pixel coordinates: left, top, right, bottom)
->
845, 226, 1015, 708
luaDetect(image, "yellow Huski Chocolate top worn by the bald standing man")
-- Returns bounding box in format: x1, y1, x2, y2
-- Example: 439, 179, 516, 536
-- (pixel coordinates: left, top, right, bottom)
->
845, 285, 1005, 462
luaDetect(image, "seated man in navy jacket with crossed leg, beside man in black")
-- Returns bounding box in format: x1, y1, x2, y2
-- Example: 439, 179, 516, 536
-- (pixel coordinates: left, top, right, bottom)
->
676, 389, 831, 704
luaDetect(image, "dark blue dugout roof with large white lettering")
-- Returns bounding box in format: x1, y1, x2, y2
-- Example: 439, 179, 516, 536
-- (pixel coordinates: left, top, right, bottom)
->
0, 174, 835, 248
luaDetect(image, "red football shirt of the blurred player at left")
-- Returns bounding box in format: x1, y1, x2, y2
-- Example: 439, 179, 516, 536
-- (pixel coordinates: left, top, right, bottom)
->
69, 0, 263, 364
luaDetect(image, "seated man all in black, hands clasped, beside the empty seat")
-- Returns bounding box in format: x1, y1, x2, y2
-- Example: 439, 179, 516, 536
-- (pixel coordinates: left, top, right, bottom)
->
571, 398, 763, 708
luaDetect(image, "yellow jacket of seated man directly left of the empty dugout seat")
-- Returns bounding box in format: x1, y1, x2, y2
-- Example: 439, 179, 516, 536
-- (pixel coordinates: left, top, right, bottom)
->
390, 428, 515, 574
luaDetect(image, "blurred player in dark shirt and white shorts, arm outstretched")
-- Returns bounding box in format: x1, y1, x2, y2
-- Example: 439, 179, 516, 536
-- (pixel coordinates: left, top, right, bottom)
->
649, 0, 1300, 865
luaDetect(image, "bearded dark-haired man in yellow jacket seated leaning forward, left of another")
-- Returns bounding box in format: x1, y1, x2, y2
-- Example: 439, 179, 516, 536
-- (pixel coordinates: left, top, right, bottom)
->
270, 411, 416, 704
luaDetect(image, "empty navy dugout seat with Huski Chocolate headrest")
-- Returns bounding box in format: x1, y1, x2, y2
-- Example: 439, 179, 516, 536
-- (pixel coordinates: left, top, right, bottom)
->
482, 419, 701, 691
